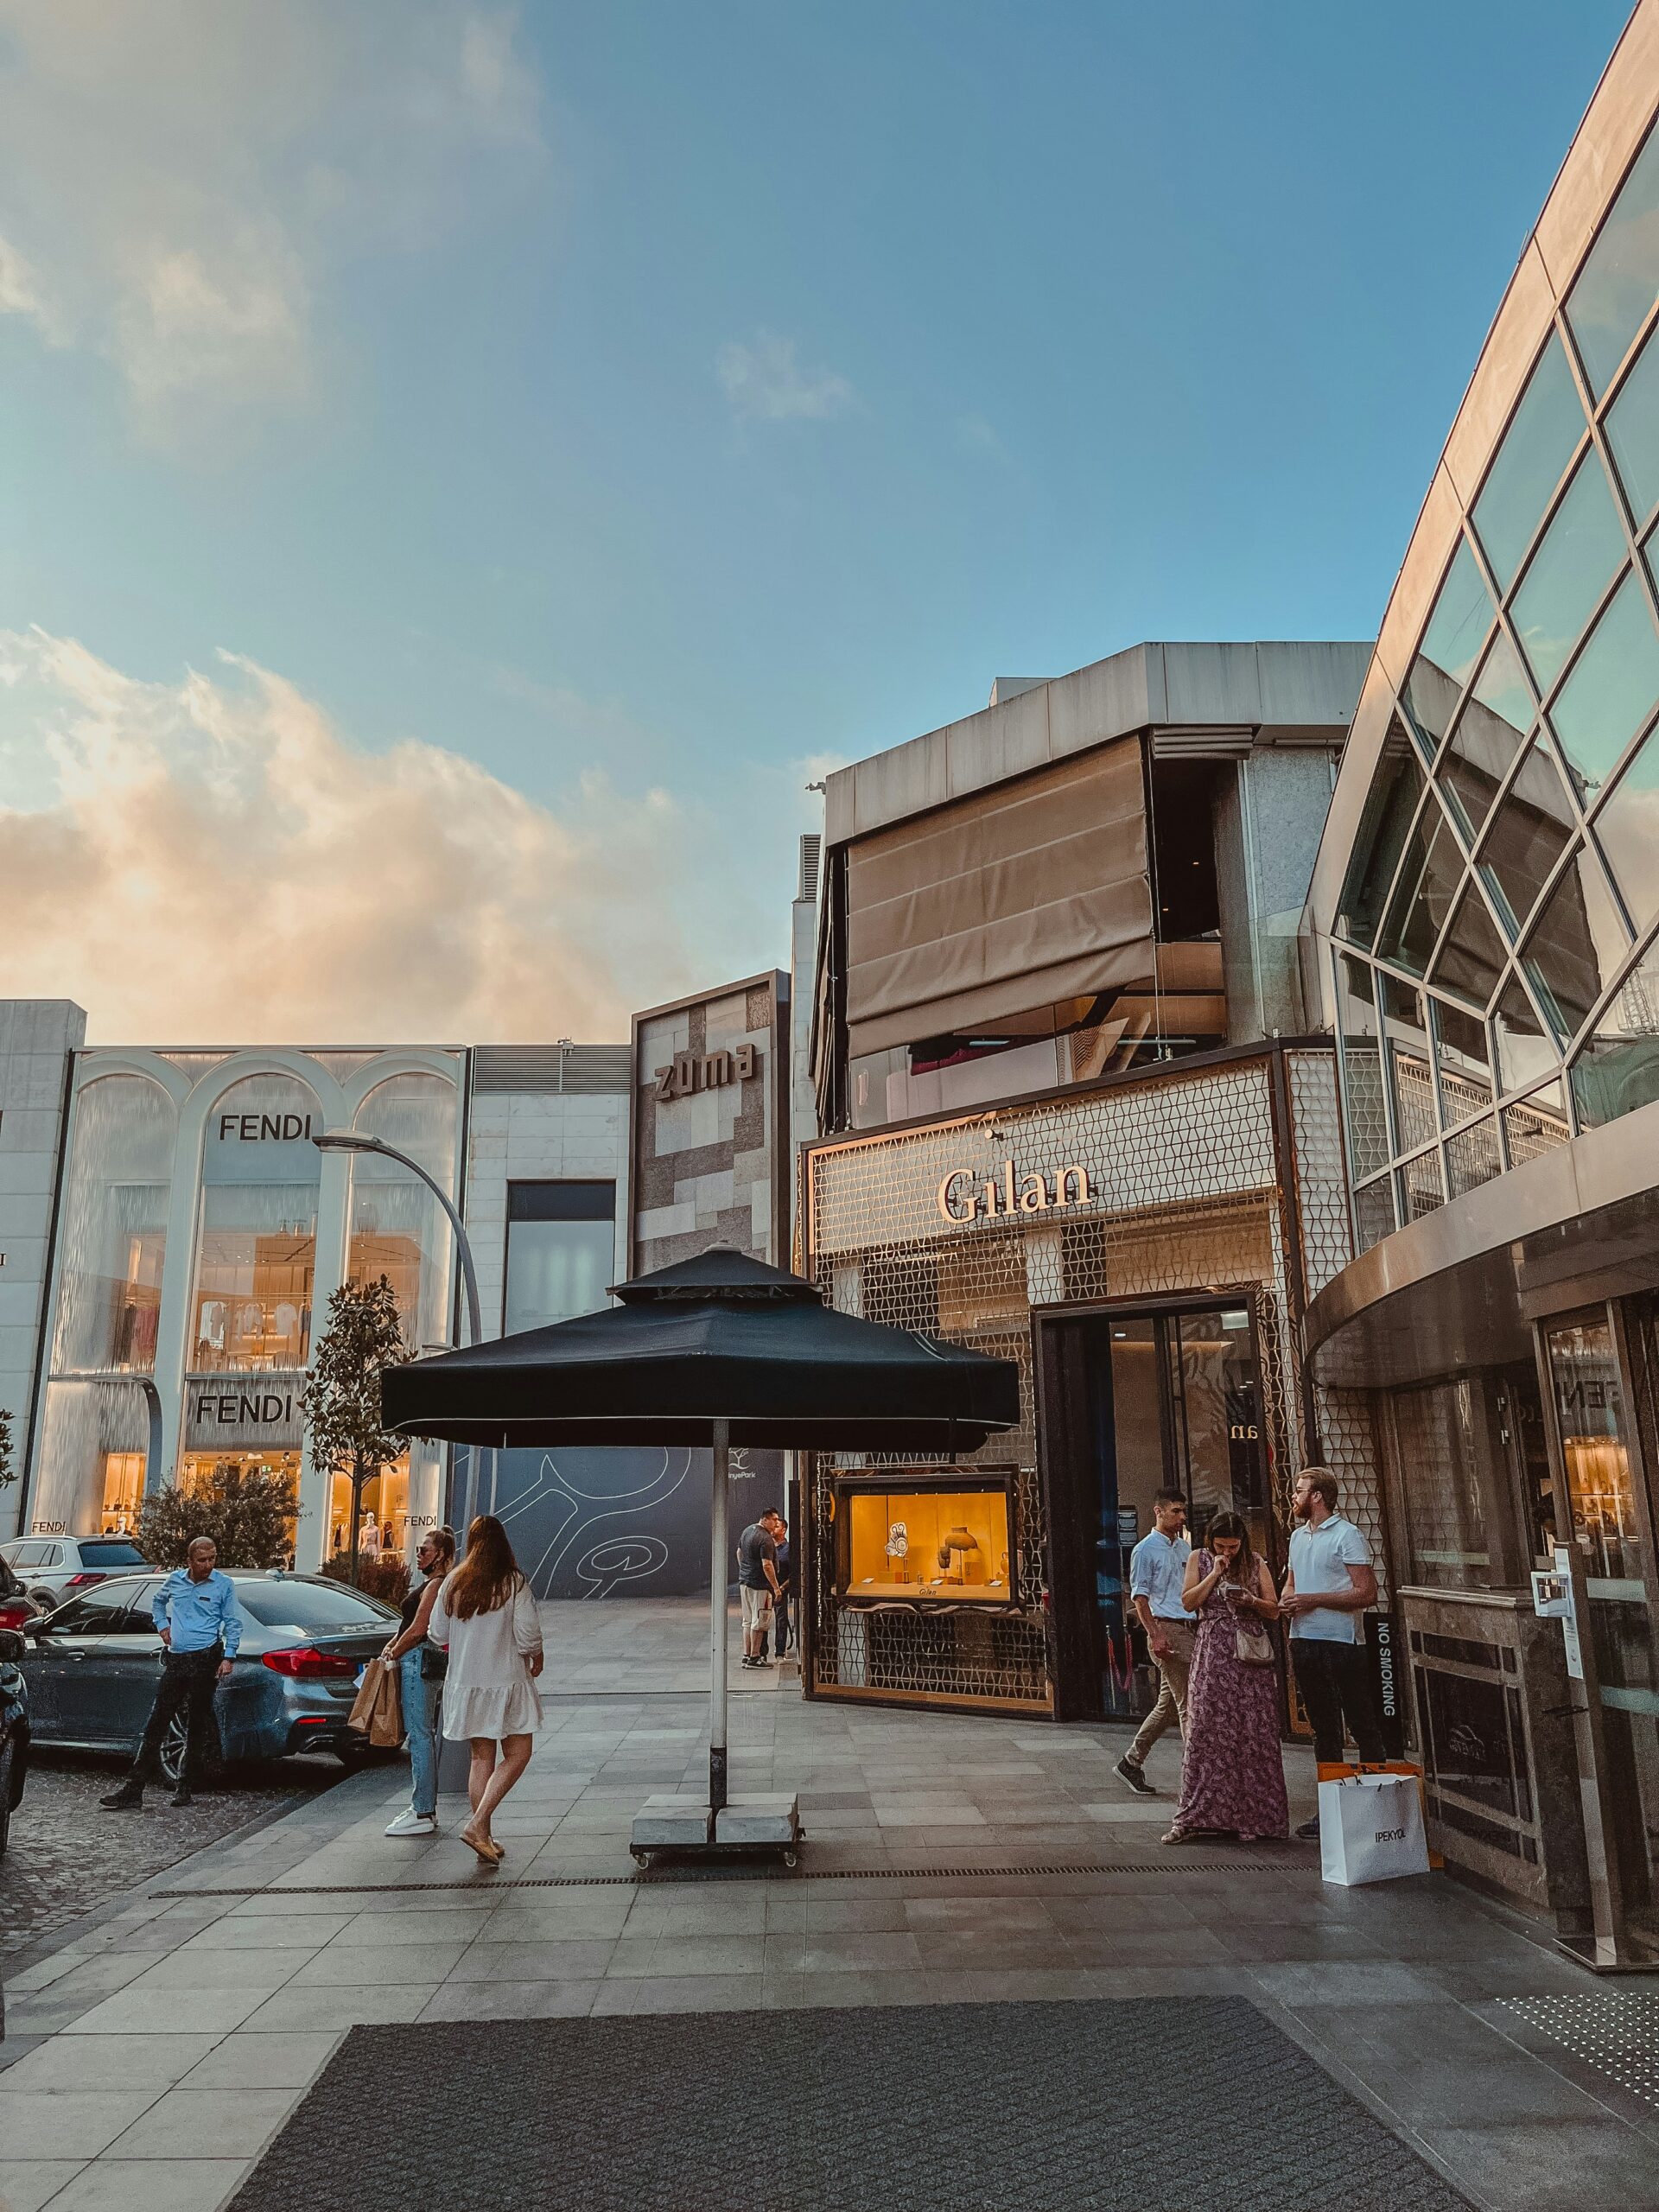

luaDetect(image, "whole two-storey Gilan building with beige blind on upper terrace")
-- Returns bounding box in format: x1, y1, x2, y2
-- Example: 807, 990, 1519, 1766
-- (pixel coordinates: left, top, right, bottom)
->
798, 646, 1387, 1721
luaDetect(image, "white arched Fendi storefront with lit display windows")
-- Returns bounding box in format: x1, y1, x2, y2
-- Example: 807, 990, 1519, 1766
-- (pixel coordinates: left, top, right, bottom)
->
24, 1046, 465, 1568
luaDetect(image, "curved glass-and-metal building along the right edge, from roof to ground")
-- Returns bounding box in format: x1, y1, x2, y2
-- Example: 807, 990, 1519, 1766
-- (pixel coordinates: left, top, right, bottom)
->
1305, 0, 1659, 1967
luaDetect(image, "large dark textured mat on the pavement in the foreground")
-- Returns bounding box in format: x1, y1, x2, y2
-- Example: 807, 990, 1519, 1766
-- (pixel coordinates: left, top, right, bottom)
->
232, 1998, 1465, 2212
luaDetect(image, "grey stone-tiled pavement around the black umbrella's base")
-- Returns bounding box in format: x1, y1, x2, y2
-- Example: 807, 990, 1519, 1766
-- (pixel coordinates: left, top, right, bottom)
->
0, 1601, 1659, 2212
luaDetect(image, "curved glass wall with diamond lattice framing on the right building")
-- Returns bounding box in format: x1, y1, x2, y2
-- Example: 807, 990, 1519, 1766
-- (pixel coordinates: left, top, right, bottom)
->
1330, 137, 1659, 1249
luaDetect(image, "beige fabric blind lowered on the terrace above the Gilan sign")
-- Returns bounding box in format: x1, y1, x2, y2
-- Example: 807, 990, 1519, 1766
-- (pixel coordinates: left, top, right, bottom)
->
847, 736, 1153, 1059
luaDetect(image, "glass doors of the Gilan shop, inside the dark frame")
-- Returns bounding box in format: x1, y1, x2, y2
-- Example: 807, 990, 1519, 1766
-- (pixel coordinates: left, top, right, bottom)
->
1082, 1305, 1276, 1719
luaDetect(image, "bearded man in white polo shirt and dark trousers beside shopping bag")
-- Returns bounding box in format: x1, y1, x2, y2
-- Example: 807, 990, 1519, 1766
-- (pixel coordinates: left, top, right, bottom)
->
1279, 1466, 1389, 1836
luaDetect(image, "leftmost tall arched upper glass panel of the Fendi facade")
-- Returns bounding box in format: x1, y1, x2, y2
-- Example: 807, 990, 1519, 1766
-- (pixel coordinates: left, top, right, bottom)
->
51, 1075, 179, 1374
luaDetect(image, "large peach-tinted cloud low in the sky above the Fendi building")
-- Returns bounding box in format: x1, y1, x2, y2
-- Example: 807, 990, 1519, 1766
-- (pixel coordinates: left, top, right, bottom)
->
0, 631, 774, 1044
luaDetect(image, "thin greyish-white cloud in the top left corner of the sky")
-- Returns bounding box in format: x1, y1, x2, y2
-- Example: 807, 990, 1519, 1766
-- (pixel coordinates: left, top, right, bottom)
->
0, 0, 544, 434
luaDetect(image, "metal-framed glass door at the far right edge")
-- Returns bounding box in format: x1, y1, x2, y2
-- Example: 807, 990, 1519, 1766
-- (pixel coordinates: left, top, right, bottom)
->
1544, 1307, 1659, 1951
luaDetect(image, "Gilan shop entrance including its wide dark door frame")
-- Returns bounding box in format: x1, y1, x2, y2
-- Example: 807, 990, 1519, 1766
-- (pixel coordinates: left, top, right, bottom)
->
1038, 1292, 1279, 1719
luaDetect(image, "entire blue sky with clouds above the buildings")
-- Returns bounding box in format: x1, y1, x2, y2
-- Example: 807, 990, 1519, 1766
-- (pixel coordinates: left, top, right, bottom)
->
0, 0, 1626, 1042
